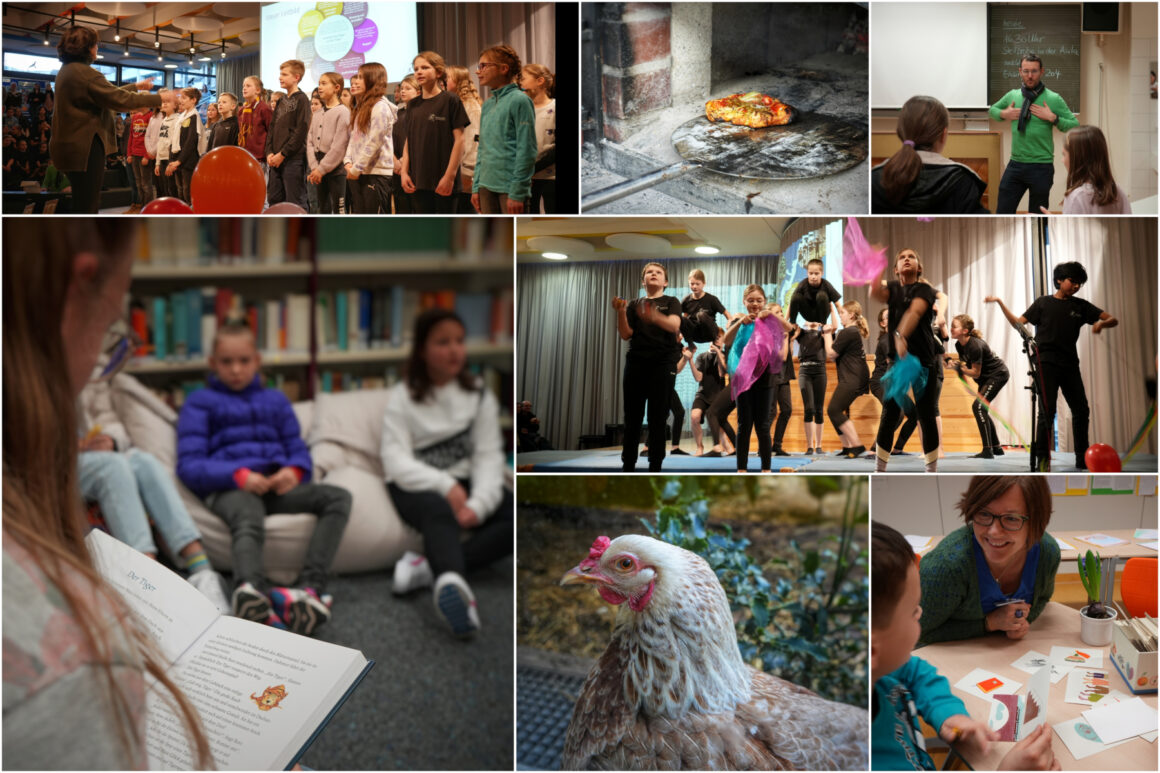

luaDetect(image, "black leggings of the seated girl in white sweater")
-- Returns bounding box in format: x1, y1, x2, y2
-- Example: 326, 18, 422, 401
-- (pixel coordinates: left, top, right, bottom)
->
386, 481, 515, 577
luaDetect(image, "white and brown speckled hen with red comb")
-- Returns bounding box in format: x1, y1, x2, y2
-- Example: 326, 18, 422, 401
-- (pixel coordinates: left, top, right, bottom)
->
560, 535, 869, 771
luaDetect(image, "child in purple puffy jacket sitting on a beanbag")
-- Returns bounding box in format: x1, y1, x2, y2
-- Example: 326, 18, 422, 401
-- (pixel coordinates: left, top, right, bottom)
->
177, 325, 350, 636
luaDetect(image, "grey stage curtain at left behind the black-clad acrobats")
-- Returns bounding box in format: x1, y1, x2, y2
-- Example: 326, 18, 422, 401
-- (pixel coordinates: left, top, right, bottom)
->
516, 255, 778, 449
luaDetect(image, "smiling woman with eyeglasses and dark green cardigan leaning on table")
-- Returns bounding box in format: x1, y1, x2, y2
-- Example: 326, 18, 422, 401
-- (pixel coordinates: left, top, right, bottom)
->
919, 475, 1059, 644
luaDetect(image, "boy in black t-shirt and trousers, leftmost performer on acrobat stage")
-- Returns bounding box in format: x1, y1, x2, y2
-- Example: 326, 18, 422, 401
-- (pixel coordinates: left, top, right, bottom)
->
612, 263, 681, 472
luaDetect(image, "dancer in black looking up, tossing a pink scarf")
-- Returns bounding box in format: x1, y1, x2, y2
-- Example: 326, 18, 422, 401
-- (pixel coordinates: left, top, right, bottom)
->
871, 248, 942, 472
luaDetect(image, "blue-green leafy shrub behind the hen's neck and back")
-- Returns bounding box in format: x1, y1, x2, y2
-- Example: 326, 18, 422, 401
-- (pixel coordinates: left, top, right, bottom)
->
641, 477, 870, 706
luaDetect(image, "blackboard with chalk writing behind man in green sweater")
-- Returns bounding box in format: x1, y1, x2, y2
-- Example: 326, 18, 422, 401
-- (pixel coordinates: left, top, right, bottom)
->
987, 2, 1080, 113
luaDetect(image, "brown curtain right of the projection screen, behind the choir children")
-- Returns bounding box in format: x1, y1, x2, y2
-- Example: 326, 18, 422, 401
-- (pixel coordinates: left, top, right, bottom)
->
424, 2, 556, 99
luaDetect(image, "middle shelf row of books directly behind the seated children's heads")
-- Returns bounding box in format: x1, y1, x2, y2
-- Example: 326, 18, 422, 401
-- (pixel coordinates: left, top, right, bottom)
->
130, 286, 514, 362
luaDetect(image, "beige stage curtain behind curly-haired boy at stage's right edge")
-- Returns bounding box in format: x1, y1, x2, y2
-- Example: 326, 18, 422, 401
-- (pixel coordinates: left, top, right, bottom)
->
1048, 217, 1157, 454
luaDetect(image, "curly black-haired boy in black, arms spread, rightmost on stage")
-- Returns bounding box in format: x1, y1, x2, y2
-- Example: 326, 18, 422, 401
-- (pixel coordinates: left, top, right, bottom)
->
986, 260, 1119, 470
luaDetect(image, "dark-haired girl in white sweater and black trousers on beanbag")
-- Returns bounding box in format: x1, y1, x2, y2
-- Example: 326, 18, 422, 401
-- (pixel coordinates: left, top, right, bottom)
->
382, 309, 514, 637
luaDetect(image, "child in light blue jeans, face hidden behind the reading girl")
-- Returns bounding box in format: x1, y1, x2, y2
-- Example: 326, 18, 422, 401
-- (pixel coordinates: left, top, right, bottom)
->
77, 331, 231, 614
